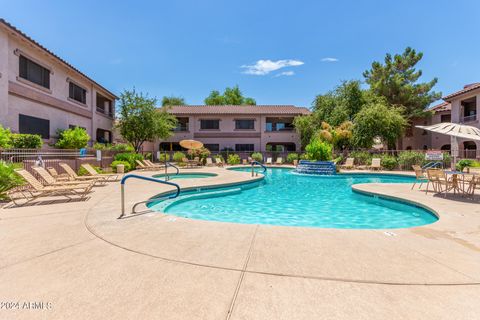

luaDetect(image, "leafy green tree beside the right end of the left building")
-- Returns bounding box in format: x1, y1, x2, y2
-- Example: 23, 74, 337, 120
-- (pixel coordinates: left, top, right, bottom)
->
117, 89, 177, 152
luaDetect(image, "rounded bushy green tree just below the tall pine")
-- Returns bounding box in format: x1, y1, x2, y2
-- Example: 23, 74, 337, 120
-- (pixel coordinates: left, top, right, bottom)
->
353, 102, 407, 149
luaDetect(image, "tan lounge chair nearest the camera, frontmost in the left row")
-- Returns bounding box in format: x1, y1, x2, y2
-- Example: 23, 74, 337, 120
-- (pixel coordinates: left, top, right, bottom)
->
11, 169, 93, 205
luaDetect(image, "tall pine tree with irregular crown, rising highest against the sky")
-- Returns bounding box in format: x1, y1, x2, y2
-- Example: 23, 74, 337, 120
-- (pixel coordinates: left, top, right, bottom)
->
363, 47, 442, 119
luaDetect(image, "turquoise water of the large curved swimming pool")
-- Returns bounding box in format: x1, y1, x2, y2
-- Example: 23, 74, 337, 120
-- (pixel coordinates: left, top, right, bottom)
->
150, 168, 437, 229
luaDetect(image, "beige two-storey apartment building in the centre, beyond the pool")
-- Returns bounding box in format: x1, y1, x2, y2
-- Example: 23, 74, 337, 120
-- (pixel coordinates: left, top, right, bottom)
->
154, 105, 310, 153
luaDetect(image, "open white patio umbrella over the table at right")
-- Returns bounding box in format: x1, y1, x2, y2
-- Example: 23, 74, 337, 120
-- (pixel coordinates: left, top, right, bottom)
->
416, 122, 480, 168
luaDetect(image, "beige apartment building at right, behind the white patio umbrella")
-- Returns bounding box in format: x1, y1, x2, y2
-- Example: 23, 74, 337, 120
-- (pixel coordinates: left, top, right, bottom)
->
402, 83, 480, 159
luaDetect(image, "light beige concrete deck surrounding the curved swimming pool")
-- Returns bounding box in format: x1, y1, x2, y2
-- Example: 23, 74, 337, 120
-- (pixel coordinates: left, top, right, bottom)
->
0, 168, 480, 319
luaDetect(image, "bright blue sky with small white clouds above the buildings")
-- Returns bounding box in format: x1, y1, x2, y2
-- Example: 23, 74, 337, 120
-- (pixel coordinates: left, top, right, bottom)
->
0, 0, 480, 106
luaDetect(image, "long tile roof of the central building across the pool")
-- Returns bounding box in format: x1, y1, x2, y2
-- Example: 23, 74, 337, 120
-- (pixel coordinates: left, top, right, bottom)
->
170, 105, 311, 115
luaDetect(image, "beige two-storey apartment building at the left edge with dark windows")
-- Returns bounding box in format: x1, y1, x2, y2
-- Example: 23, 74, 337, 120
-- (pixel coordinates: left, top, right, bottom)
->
0, 19, 116, 144
